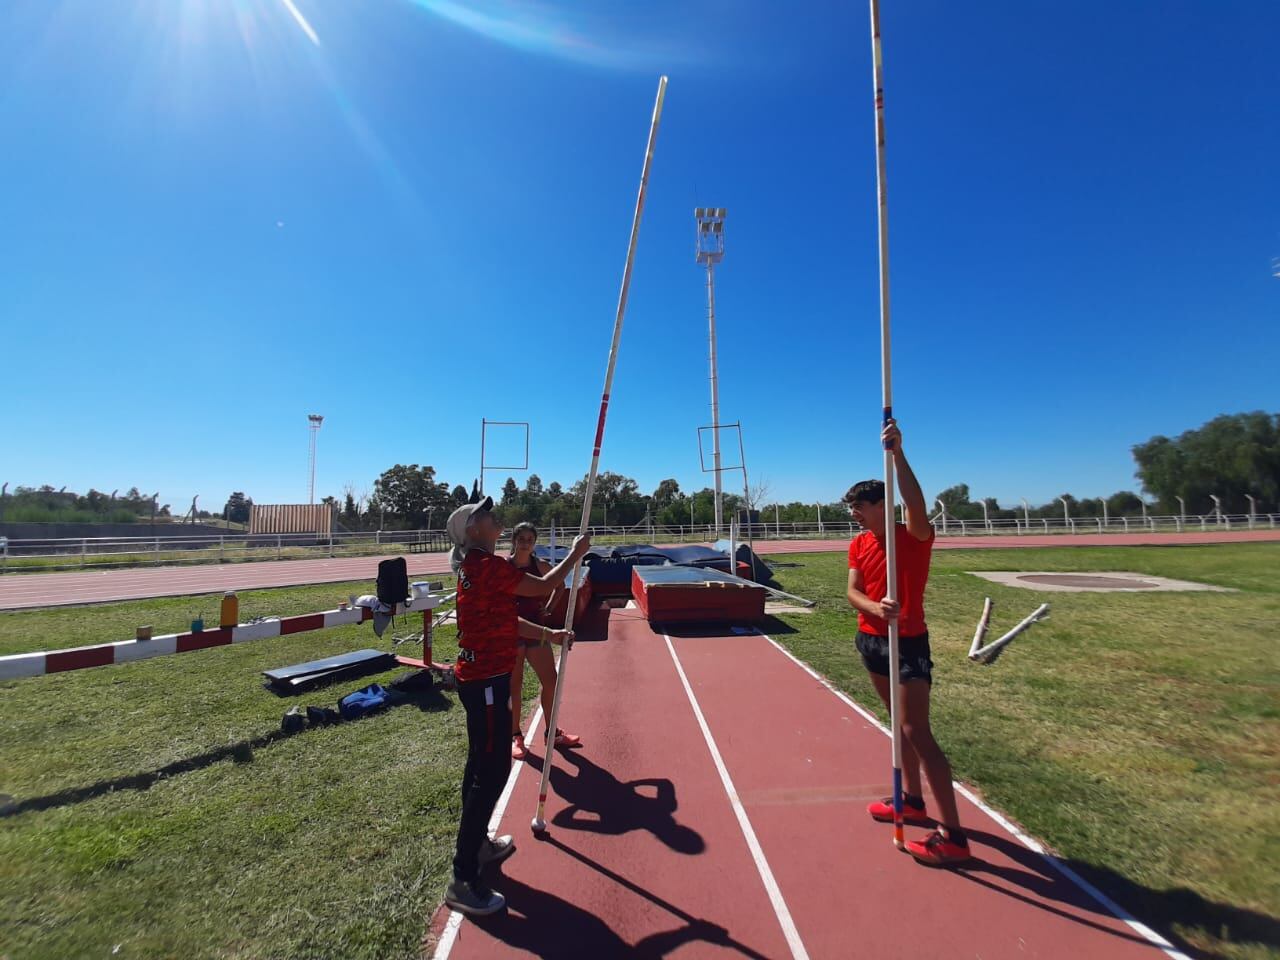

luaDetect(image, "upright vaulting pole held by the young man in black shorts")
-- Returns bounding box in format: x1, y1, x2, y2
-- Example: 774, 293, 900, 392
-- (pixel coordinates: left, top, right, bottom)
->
870, 0, 906, 850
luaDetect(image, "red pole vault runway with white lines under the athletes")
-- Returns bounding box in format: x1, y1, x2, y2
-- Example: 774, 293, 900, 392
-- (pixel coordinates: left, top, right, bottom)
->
428, 611, 1179, 960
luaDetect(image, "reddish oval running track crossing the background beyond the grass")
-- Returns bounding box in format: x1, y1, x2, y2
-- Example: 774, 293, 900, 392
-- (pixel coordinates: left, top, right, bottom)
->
0, 530, 1280, 611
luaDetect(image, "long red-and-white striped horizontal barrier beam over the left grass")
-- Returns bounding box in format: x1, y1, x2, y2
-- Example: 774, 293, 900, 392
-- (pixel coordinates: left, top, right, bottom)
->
0, 596, 444, 680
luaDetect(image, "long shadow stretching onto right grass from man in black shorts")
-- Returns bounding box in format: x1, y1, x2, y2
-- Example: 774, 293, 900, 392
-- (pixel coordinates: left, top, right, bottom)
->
956, 829, 1280, 957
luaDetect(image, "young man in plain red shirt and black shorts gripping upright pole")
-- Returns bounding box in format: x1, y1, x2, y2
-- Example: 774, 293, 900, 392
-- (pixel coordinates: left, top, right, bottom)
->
845, 420, 969, 867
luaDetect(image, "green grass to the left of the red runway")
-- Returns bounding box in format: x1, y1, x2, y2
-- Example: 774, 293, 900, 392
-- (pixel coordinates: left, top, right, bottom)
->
0, 582, 517, 959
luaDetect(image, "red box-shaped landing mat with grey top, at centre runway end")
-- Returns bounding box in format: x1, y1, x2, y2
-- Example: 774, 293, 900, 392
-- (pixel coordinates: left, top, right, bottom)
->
631, 566, 764, 623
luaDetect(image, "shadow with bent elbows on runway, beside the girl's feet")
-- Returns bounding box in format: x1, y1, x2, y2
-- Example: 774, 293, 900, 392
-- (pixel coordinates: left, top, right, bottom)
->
530, 751, 707, 855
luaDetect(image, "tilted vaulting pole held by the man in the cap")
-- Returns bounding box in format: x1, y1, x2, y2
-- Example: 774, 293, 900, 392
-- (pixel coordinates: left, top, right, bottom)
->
530, 77, 667, 832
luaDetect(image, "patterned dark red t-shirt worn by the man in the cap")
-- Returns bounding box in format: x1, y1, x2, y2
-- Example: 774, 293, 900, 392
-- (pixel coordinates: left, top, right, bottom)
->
454, 547, 525, 681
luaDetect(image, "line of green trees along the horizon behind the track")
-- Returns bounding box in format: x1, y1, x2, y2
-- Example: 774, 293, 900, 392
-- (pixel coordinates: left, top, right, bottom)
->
10, 411, 1280, 530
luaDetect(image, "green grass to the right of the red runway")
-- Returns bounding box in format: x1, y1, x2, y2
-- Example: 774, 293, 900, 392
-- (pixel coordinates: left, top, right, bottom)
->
776, 544, 1280, 957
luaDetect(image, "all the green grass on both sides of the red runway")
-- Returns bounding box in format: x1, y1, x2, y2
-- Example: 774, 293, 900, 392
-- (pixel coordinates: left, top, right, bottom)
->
0, 544, 1280, 960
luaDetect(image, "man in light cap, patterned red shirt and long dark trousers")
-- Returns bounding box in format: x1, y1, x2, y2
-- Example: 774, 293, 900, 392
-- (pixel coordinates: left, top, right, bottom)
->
444, 497, 591, 916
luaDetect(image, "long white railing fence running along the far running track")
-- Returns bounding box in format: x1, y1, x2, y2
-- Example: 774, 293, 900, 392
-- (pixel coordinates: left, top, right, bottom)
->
0, 513, 1280, 572
